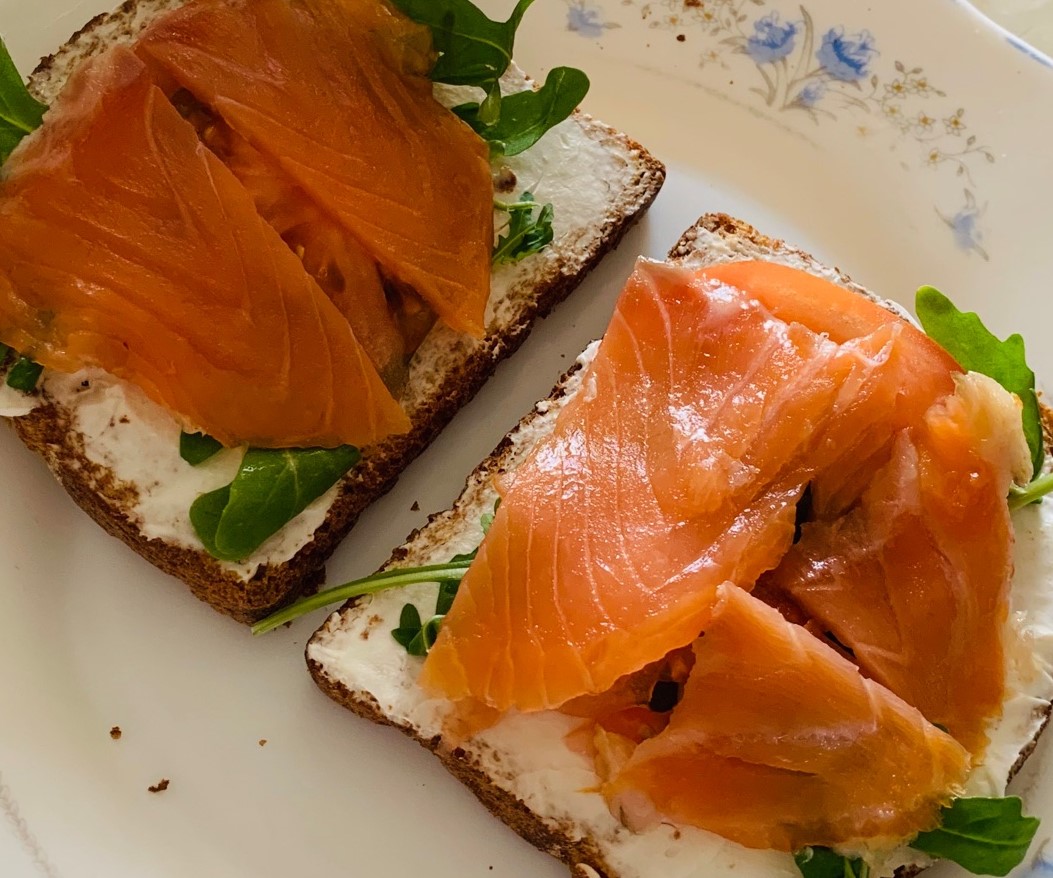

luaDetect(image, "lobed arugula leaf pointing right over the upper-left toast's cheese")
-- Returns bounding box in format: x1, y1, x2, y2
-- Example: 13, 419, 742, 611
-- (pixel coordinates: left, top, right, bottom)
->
454, 67, 589, 159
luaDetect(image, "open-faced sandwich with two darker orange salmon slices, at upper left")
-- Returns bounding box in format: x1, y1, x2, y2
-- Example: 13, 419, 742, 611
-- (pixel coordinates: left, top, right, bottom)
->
0, 0, 664, 621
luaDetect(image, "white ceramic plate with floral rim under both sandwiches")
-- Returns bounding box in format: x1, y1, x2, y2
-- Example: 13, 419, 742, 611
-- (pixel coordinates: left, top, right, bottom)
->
0, 0, 1053, 878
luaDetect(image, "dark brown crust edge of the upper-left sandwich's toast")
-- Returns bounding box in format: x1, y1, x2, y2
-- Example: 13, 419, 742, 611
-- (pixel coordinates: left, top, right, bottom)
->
14, 0, 665, 622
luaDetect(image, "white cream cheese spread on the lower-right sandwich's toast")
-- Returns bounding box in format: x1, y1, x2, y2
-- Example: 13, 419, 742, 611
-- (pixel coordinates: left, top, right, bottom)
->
307, 344, 1053, 878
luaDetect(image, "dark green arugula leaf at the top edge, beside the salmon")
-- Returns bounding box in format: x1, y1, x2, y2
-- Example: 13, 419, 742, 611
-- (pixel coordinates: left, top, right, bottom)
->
395, 0, 533, 94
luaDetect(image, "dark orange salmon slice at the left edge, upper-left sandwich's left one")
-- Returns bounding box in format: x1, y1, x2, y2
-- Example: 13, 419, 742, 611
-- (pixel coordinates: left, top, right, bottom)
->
0, 48, 409, 447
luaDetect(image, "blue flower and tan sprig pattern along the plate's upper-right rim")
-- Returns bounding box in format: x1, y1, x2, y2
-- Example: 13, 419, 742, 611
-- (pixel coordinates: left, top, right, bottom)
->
567, 0, 995, 259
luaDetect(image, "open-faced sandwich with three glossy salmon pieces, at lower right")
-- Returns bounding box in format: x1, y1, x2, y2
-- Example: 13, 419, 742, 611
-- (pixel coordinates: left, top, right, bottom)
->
296, 215, 1053, 878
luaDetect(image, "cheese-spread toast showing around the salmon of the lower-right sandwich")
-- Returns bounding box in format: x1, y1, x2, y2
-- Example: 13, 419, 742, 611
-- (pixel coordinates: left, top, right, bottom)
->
306, 215, 1053, 878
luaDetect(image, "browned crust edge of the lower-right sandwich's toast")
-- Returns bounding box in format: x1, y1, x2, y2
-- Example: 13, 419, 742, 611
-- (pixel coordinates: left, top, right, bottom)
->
305, 214, 1053, 878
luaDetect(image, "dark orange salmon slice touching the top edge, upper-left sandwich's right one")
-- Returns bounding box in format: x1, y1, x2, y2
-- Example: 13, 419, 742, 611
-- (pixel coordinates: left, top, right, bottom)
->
137, 0, 493, 336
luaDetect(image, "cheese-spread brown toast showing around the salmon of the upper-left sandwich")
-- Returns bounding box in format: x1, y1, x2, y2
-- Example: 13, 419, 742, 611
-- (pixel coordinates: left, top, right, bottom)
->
0, 0, 664, 622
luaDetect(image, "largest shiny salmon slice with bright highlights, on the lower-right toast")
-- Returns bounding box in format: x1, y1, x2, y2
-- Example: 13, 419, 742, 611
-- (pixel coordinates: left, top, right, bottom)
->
421, 262, 957, 711
